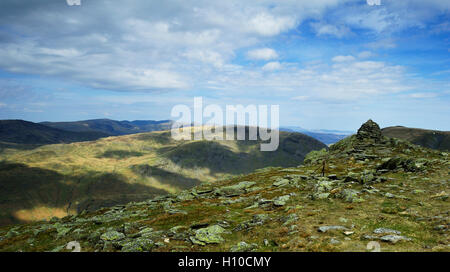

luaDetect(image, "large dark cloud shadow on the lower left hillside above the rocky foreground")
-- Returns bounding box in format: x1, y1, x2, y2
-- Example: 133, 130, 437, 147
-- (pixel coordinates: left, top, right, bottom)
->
0, 162, 167, 225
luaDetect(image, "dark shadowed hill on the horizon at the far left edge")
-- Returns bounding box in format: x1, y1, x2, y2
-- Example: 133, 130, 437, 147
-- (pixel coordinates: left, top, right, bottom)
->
0, 120, 108, 145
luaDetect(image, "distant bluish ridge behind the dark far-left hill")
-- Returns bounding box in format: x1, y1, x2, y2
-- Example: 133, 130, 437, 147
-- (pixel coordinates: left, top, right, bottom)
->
41, 119, 173, 136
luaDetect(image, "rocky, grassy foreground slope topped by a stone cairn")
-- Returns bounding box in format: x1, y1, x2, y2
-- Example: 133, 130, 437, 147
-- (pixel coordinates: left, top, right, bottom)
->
0, 121, 450, 252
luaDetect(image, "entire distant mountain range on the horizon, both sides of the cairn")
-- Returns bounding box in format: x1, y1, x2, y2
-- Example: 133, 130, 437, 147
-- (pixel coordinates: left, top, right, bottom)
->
0, 119, 450, 150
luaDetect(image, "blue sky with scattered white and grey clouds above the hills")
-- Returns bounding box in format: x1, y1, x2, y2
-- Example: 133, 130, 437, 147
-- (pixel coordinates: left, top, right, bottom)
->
0, 0, 450, 131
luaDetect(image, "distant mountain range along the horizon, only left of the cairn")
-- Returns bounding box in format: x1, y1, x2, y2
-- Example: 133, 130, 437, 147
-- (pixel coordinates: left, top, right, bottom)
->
0, 119, 353, 145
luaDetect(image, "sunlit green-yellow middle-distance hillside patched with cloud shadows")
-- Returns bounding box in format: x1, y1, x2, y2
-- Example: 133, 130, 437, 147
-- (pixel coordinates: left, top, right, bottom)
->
0, 127, 324, 225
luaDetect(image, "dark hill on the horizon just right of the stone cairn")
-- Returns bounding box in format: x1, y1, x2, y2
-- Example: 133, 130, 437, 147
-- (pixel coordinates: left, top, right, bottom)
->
381, 126, 450, 151
